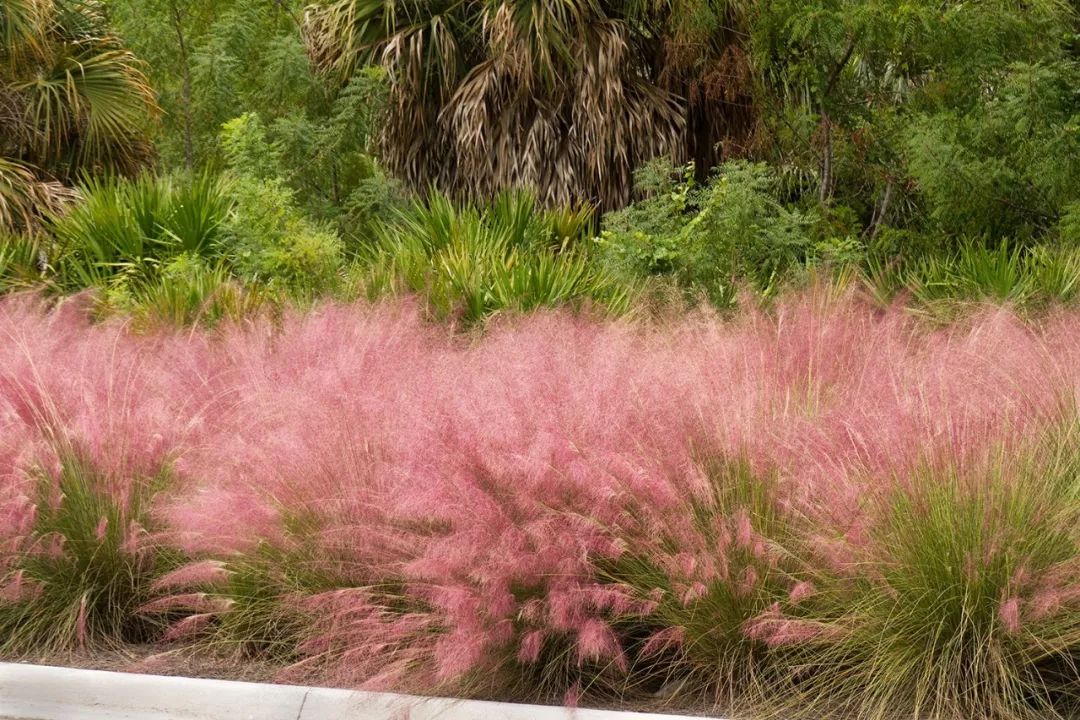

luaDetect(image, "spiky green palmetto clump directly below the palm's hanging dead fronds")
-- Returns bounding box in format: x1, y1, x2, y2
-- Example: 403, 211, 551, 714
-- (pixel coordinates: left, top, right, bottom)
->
359, 192, 634, 324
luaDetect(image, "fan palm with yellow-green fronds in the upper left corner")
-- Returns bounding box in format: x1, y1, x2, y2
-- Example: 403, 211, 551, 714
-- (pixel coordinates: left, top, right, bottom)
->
0, 0, 157, 228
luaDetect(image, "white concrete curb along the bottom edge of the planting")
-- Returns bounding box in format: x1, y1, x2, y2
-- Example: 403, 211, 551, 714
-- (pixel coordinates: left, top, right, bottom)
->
0, 663, 721, 720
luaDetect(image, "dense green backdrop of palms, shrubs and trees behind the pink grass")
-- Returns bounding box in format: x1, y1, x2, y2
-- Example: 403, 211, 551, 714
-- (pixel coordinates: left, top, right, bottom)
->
0, 0, 1080, 322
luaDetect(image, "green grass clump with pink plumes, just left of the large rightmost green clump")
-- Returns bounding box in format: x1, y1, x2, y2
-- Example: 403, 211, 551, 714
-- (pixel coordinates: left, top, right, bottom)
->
599, 459, 831, 711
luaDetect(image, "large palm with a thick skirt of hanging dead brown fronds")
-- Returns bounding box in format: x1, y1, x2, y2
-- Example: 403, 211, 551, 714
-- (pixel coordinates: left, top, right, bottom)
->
306, 0, 750, 207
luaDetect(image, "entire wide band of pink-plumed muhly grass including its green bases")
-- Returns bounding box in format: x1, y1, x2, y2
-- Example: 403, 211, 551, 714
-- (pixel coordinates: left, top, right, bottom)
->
0, 293, 1080, 718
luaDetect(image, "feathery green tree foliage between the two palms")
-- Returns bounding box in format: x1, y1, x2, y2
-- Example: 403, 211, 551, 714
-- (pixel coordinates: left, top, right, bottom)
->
108, 0, 405, 245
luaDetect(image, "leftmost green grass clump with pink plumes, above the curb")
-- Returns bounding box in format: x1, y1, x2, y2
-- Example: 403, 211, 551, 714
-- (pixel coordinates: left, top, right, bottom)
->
0, 451, 179, 653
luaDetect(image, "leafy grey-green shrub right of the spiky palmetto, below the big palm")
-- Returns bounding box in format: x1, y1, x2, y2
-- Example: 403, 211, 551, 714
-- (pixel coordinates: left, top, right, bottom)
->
600, 162, 814, 305
